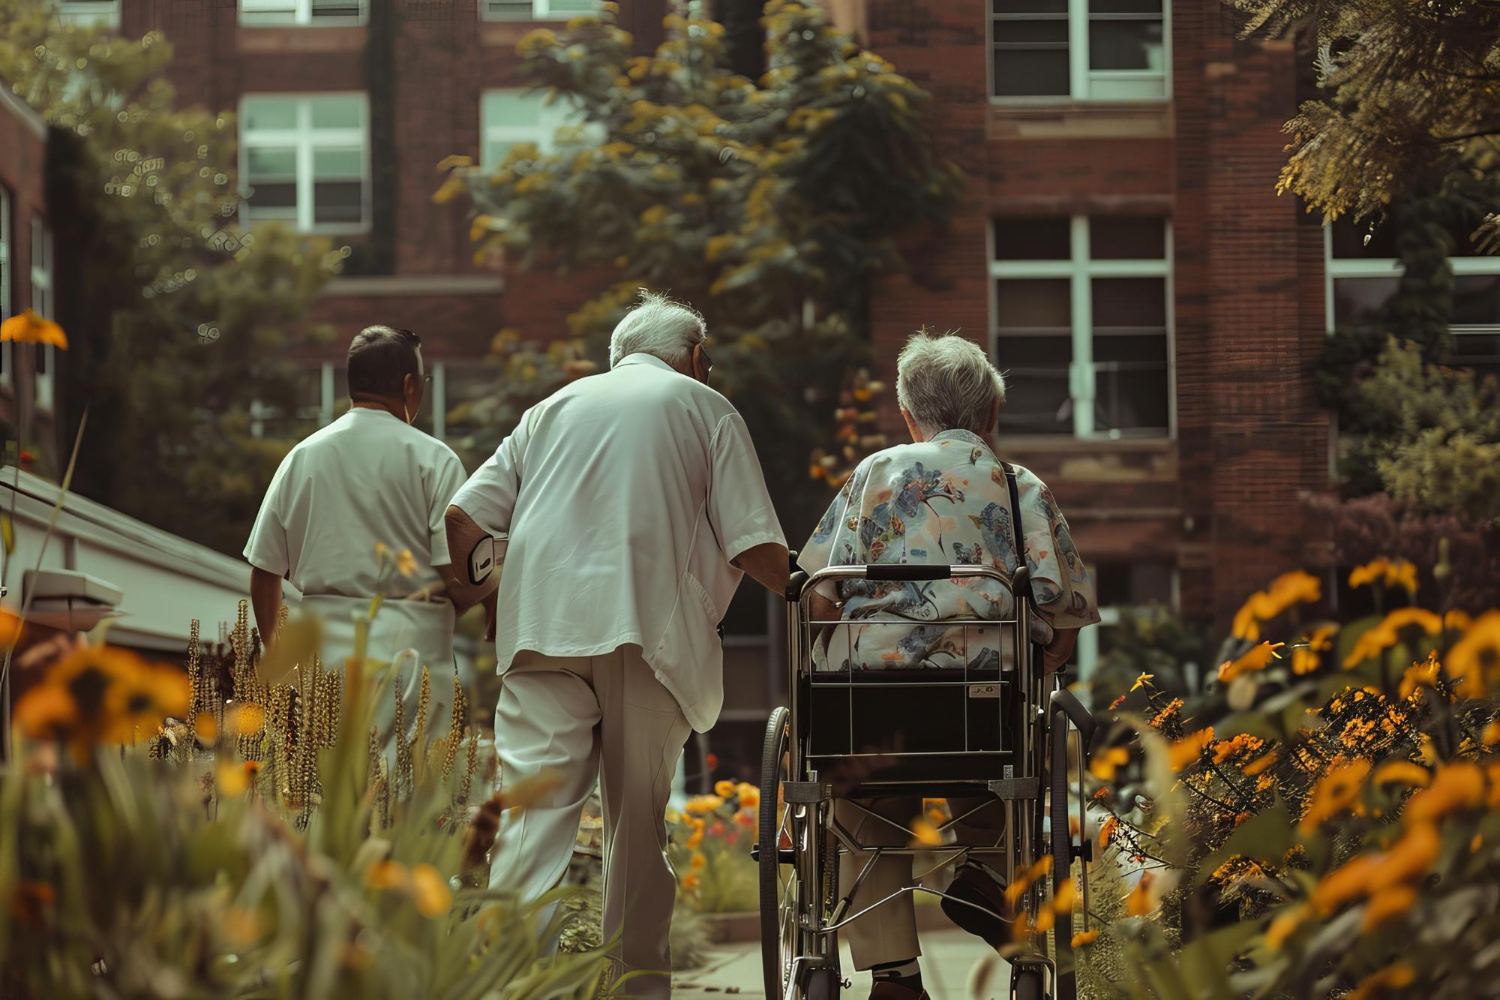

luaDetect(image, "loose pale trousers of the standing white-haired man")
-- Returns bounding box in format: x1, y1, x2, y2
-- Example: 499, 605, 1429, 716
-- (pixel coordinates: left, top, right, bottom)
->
489, 646, 690, 997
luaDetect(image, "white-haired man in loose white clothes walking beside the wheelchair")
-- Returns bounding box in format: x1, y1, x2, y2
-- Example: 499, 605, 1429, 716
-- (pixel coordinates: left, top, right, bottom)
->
447, 292, 788, 996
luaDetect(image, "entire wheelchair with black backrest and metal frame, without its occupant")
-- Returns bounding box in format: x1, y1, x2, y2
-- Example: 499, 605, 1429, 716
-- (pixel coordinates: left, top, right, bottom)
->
755, 564, 1094, 1000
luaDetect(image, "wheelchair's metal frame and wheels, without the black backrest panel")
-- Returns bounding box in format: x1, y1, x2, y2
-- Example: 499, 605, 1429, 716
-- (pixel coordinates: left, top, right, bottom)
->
755, 564, 1094, 1000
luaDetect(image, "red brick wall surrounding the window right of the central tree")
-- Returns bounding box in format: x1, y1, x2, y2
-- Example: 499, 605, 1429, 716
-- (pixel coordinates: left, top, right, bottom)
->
858, 0, 1329, 621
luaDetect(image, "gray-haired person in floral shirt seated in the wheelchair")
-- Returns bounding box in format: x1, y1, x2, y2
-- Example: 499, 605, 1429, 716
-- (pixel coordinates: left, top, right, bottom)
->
798, 331, 1100, 1000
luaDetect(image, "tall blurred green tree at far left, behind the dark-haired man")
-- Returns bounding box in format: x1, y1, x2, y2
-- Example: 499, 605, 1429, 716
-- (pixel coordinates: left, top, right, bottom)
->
0, 0, 344, 550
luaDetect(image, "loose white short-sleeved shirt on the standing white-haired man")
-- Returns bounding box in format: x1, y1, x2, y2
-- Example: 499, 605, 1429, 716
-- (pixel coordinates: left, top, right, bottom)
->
453, 354, 786, 732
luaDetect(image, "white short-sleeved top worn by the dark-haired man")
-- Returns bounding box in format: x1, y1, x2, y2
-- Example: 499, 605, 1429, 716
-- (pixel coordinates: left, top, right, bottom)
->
245, 406, 464, 667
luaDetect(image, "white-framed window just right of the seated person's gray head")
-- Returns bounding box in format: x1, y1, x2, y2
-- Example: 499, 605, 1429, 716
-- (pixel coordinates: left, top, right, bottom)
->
990, 216, 1172, 438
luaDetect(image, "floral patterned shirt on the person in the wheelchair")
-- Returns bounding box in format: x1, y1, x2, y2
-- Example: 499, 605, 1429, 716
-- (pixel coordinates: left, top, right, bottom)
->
798, 430, 1100, 669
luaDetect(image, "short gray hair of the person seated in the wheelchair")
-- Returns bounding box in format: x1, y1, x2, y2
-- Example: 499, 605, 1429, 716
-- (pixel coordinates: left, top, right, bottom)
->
896, 328, 1005, 436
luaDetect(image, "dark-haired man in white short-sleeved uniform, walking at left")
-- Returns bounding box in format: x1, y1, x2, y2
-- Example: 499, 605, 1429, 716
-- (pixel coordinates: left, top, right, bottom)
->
245, 327, 467, 733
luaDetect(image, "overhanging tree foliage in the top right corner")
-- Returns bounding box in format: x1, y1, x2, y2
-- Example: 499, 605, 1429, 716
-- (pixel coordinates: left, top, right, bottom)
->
1226, 0, 1500, 226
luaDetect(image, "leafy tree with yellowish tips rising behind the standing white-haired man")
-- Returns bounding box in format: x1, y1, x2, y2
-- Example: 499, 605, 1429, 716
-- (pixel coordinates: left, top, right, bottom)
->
435, 0, 959, 527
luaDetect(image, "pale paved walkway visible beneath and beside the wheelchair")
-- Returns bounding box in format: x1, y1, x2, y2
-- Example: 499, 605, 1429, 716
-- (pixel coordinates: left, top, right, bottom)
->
672, 931, 1010, 1000
